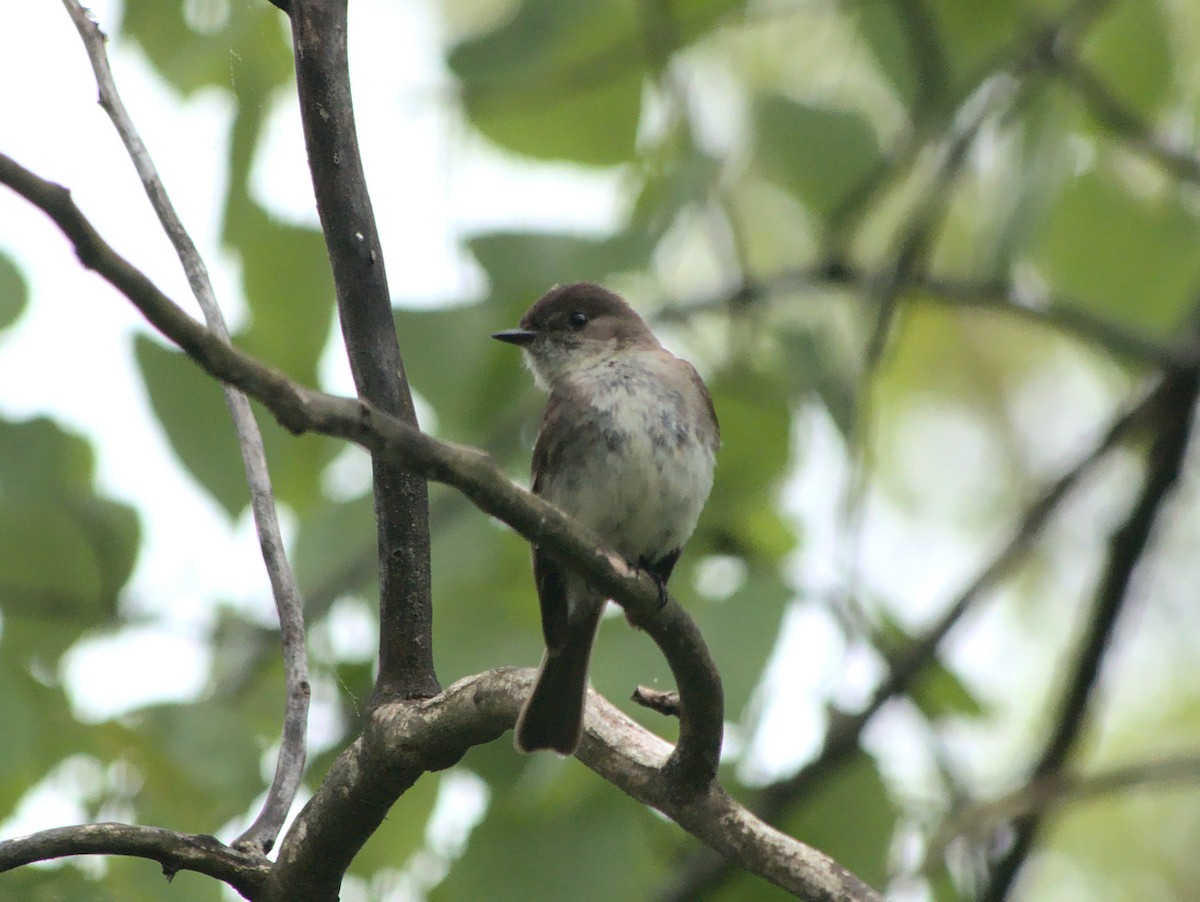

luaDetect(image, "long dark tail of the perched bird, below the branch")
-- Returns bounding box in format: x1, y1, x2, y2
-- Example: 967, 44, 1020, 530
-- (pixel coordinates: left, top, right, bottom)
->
514, 603, 604, 754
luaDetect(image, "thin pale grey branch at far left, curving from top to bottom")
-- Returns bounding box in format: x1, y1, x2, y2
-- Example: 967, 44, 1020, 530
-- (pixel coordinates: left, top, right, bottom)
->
62, 0, 310, 853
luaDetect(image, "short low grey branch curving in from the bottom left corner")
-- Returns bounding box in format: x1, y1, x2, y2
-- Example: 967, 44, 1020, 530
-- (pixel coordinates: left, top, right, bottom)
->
0, 824, 271, 898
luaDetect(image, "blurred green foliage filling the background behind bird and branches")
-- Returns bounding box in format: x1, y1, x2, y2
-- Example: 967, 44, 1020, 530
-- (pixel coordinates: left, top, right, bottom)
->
0, 0, 1200, 902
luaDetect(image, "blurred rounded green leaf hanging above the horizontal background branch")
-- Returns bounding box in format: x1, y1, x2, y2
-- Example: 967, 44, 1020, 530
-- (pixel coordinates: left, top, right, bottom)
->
755, 94, 883, 225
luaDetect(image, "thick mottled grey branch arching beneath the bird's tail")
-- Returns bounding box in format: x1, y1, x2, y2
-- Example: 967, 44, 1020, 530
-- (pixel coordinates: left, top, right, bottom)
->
265, 668, 880, 902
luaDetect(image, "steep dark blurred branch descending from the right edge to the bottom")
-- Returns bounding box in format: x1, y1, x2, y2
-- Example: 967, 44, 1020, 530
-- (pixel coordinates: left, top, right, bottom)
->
980, 367, 1200, 902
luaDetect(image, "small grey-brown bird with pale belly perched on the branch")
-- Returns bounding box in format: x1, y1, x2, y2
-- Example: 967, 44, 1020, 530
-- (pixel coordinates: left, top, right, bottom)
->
492, 282, 720, 754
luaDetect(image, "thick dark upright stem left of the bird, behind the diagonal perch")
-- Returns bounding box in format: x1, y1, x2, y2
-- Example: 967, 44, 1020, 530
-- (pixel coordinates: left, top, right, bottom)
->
290, 0, 440, 703
